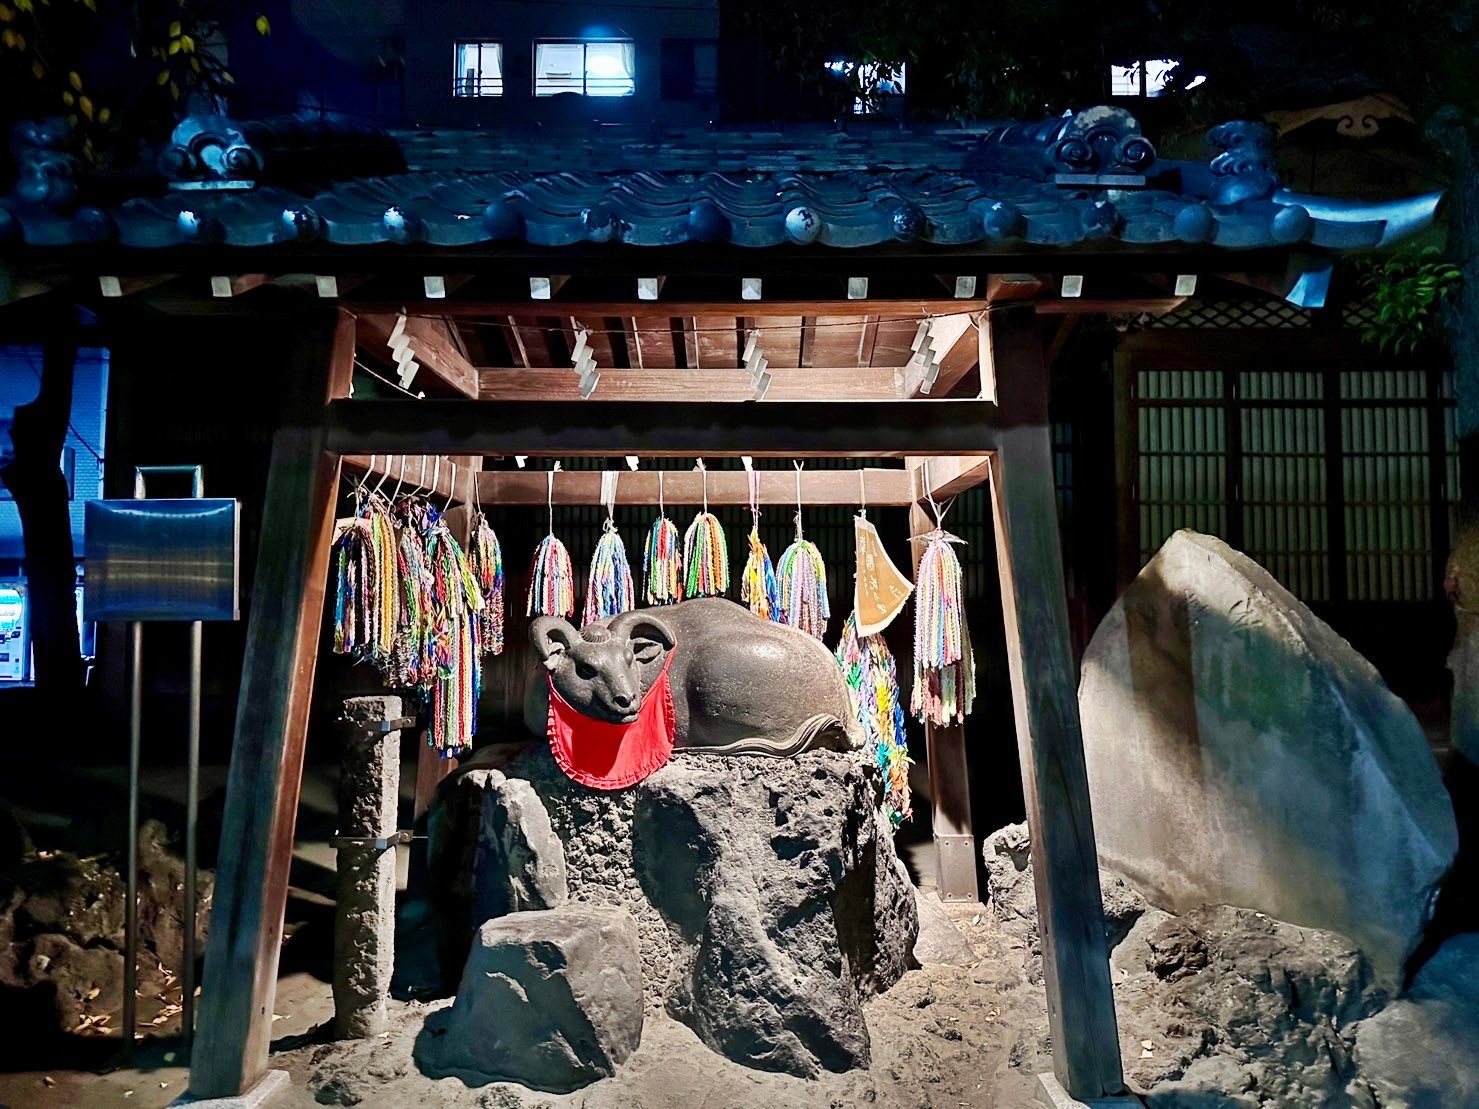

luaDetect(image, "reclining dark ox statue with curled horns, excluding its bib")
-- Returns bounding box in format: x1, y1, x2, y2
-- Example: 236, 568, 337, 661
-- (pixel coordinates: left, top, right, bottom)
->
525, 597, 864, 757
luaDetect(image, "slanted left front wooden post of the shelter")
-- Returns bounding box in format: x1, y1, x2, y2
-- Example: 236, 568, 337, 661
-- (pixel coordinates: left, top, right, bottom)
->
189, 311, 355, 1099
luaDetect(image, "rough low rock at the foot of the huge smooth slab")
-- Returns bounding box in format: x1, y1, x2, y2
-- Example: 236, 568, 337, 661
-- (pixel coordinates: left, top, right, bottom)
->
1109, 905, 1386, 1109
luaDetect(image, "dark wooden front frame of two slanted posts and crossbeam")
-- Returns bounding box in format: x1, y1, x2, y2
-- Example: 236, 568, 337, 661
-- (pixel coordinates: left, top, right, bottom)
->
191, 302, 1124, 1100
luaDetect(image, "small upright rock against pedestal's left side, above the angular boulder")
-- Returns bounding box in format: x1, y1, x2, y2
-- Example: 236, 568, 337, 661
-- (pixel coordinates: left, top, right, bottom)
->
472, 770, 569, 920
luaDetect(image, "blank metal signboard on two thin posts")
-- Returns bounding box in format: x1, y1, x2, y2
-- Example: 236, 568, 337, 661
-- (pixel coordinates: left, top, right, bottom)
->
84, 466, 240, 1056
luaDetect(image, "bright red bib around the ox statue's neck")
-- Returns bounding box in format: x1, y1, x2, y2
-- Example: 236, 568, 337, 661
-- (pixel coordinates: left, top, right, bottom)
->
546, 654, 677, 790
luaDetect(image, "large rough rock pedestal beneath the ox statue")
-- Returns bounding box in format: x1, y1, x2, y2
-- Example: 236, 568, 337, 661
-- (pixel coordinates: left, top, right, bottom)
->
443, 745, 918, 1076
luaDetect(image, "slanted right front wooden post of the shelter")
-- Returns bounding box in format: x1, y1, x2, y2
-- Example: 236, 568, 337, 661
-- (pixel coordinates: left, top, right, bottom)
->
988, 306, 1124, 1102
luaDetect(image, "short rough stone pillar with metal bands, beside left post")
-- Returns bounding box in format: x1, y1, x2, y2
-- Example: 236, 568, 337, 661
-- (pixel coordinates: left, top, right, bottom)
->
334, 696, 402, 1040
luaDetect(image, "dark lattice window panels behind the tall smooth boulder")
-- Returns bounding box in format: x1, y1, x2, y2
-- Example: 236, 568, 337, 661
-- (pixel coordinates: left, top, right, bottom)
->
1130, 365, 1460, 603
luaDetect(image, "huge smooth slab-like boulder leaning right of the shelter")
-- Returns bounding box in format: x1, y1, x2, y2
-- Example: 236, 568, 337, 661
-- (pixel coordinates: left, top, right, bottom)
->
1078, 531, 1457, 983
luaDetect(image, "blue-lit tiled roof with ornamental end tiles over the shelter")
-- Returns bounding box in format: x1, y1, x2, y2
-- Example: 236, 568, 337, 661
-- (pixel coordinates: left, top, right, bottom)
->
0, 108, 1442, 257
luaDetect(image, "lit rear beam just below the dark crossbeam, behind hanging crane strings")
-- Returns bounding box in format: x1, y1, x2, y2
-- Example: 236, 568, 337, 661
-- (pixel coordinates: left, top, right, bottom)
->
478, 467, 914, 506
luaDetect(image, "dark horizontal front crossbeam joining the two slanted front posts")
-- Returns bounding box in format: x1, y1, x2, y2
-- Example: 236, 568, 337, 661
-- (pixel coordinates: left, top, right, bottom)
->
328, 399, 995, 458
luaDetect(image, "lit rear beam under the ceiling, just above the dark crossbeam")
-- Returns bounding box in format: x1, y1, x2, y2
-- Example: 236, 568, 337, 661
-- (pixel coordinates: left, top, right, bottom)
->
478, 367, 902, 404
